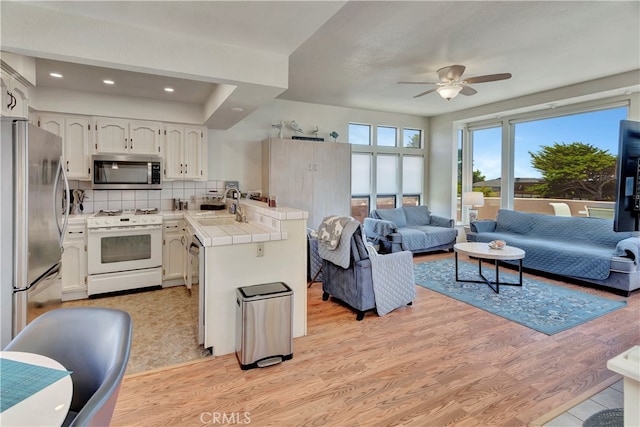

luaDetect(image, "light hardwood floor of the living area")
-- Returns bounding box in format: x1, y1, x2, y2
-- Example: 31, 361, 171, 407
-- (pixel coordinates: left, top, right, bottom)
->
112, 253, 640, 426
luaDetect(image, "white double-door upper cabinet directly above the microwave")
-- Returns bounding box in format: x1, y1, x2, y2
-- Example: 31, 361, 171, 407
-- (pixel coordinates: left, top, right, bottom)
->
95, 117, 162, 155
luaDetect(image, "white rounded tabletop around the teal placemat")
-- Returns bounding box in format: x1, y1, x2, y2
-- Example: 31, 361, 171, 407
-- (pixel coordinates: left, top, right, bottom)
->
0, 351, 73, 427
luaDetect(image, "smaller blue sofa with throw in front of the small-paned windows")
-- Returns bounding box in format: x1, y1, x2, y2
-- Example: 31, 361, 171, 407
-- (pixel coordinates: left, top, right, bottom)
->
364, 206, 458, 253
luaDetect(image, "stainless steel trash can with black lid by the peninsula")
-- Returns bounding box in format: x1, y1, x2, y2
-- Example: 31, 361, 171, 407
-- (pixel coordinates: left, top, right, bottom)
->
236, 282, 293, 369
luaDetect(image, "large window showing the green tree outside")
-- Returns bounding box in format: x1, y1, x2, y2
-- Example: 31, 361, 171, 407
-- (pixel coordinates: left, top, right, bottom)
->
512, 107, 627, 216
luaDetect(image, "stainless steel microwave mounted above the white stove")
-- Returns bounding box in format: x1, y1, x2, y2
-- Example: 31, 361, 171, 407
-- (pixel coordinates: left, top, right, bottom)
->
93, 154, 162, 190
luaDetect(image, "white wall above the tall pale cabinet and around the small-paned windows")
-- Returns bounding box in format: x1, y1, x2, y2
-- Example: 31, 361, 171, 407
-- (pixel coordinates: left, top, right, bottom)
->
209, 99, 429, 191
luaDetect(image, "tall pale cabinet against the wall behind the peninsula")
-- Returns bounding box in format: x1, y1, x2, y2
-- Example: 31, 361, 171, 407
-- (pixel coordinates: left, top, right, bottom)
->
262, 139, 351, 229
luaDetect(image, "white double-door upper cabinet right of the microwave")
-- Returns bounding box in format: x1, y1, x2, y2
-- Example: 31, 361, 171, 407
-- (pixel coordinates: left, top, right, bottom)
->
164, 125, 207, 180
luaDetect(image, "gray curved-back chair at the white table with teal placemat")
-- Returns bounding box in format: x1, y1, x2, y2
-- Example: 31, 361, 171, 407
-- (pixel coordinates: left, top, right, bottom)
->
4, 307, 132, 427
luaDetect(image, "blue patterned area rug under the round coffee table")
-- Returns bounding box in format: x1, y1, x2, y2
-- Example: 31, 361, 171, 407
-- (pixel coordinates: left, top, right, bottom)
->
414, 258, 627, 335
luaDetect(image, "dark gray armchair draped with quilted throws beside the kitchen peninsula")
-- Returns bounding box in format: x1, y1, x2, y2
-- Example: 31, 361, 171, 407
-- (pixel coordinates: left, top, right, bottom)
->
321, 224, 416, 320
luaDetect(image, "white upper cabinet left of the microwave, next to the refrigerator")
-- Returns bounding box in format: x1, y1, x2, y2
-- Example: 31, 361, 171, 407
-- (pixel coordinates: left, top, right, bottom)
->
38, 114, 91, 180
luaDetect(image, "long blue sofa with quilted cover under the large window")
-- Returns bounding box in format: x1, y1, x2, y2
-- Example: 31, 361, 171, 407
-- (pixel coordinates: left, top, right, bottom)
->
467, 209, 640, 296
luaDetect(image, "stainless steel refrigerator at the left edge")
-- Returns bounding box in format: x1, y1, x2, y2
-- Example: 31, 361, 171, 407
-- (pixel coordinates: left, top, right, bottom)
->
0, 117, 70, 348
